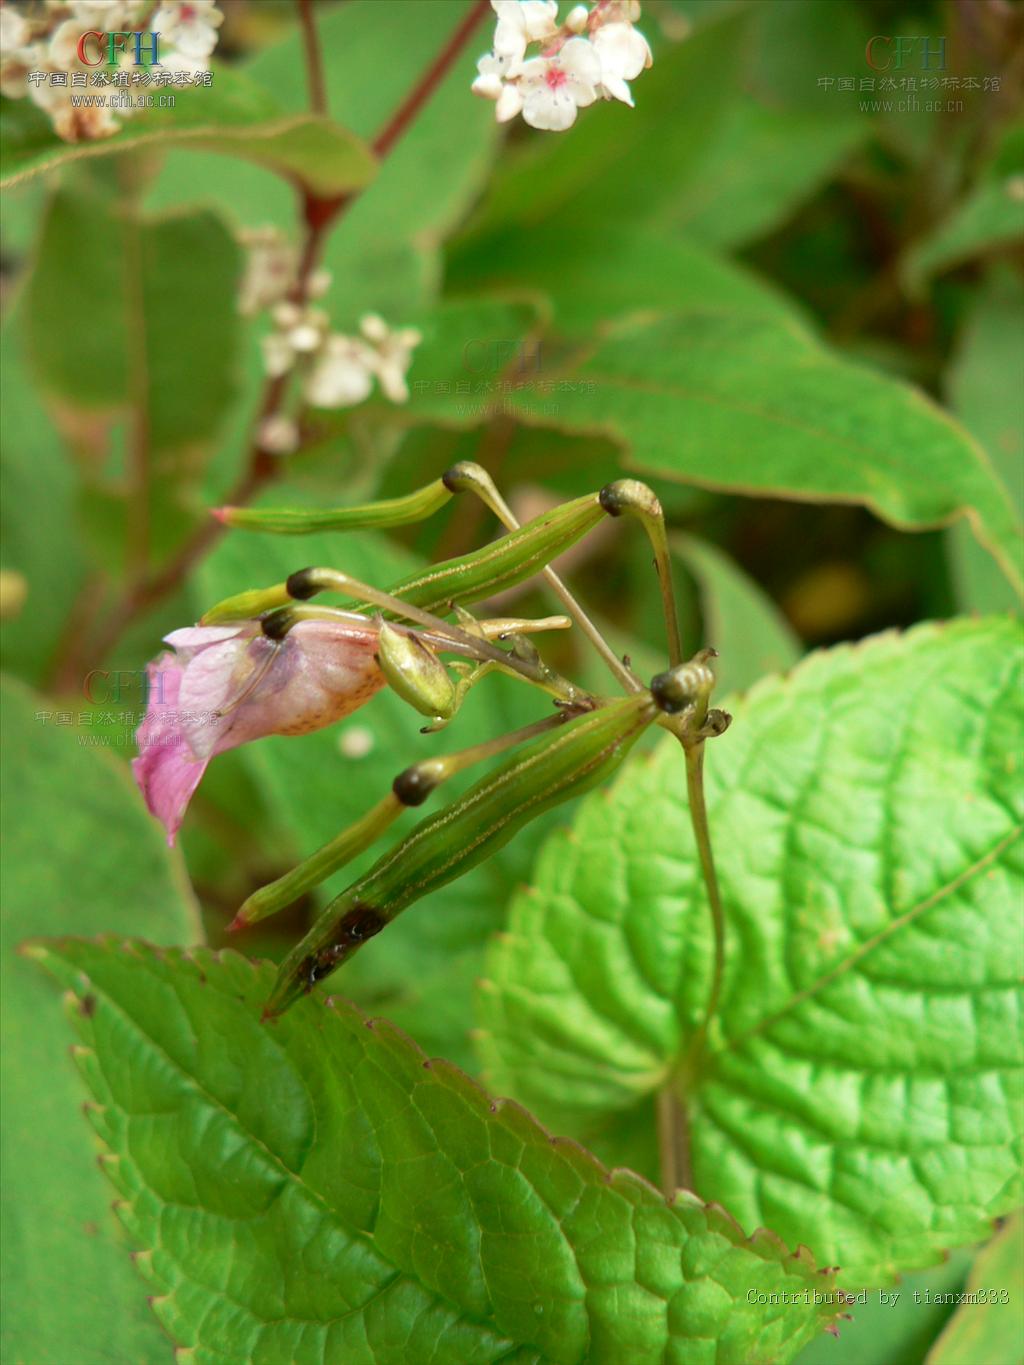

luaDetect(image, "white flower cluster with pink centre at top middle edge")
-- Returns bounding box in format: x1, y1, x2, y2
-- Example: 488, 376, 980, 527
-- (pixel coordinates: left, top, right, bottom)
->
472, 0, 651, 132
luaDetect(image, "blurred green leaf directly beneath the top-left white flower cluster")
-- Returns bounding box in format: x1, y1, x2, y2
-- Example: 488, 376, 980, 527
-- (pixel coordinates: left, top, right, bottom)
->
0, 67, 374, 195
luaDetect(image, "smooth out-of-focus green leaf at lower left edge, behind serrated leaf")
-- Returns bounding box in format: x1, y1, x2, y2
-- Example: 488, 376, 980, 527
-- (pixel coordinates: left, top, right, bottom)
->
0, 681, 198, 1365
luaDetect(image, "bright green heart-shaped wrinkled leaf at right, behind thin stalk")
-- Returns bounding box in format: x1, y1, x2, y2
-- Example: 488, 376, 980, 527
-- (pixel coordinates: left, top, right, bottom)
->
478, 618, 1024, 1286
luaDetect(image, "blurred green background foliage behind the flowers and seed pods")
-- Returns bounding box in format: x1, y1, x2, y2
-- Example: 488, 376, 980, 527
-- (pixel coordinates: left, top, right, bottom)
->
0, 0, 1024, 1365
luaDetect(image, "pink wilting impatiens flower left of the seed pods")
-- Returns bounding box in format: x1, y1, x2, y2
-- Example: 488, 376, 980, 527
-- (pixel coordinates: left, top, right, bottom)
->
131, 621, 384, 845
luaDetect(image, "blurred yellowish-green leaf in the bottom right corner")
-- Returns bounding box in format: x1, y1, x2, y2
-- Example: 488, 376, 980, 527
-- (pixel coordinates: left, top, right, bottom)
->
927, 1213, 1024, 1365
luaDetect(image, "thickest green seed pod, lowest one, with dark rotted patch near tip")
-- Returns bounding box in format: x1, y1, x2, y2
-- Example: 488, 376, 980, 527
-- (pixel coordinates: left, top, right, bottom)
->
264, 692, 658, 1017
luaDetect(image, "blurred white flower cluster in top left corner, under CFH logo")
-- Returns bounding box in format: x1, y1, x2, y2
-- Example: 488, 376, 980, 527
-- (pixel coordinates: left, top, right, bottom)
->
0, 0, 224, 142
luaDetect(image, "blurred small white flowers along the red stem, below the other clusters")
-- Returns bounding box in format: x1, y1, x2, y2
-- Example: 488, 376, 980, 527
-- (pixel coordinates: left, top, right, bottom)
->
239, 228, 422, 455
